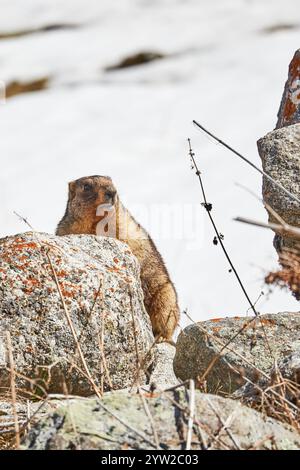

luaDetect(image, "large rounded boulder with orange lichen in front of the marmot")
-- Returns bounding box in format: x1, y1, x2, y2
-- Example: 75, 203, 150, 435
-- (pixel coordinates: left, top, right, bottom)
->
0, 232, 154, 395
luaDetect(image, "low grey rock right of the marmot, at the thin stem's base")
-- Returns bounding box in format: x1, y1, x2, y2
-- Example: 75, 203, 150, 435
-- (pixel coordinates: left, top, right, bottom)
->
174, 313, 300, 393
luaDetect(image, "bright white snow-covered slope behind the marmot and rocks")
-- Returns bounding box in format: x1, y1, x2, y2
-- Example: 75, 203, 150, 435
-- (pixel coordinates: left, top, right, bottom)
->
0, 0, 300, 325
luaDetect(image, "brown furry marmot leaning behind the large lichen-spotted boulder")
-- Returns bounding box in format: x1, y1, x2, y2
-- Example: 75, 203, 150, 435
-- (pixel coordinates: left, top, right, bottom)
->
56, 176, 179, 341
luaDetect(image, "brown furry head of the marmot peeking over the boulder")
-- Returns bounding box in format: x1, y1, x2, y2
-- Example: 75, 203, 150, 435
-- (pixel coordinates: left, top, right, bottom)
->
68, 176, 118, 232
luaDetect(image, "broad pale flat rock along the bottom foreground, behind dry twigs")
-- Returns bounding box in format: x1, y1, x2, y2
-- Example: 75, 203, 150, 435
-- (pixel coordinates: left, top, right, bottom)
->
23, 389, 300, 450
